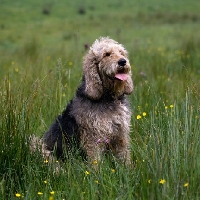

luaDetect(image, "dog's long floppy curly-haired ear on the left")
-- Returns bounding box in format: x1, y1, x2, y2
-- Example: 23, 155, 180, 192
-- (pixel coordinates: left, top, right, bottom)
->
83, 49, 103, 100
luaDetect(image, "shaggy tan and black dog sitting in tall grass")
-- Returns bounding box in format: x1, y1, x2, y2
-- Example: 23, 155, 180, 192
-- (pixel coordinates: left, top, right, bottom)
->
43, 37, 133, 164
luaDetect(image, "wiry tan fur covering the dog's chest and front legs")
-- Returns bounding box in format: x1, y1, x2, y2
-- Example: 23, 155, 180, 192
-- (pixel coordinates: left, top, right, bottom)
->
73, 97, 131, 163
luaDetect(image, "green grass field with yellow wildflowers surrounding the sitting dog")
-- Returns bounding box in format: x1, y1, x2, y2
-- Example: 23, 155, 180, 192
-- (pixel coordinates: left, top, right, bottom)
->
0, 0, 200, 200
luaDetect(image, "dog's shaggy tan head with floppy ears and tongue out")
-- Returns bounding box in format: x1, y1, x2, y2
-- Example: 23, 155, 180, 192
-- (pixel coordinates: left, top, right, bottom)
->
83, 37, 133, 100
